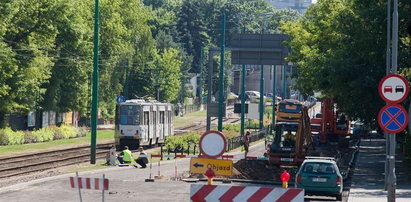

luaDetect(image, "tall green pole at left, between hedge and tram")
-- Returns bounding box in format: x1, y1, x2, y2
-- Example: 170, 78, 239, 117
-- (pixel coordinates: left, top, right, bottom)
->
90, 0, 99, 164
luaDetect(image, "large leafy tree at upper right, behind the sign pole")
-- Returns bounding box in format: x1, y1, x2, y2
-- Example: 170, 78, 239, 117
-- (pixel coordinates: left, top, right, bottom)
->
282, 0, 411, 123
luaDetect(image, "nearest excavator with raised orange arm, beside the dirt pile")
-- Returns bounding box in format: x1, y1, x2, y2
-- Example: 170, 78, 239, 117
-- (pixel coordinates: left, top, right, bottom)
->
269, 106, 313, 165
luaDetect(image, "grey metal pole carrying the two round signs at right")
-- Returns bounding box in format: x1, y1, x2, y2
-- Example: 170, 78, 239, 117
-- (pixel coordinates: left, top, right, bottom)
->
387, 0, 398, 202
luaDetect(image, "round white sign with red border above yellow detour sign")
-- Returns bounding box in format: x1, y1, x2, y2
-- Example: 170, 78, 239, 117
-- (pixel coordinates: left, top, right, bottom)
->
200, 130, 227, 158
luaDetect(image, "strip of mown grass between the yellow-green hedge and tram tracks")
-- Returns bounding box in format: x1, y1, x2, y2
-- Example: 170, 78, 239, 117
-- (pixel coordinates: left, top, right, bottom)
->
0, 130, 114, 155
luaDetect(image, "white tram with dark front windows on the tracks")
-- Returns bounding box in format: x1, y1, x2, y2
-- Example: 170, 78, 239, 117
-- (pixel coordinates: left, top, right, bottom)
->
115, 99, 174, 149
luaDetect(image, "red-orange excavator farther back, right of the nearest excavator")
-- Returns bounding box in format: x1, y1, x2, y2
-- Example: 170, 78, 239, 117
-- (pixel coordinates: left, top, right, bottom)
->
311, 98, 350, 147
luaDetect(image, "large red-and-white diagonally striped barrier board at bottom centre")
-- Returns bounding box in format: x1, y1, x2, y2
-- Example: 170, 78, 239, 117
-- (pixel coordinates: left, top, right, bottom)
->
190, 184, 304, 202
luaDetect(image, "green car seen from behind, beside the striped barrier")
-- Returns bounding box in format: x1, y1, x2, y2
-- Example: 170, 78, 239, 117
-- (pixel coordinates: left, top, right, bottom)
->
295, 157, 343, 201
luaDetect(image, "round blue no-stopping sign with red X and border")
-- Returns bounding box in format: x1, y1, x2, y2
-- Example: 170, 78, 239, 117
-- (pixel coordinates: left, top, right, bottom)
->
378, 104, 408, 133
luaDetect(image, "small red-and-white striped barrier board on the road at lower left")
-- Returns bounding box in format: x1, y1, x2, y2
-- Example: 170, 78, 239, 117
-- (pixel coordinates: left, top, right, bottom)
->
70, 177, 108, 190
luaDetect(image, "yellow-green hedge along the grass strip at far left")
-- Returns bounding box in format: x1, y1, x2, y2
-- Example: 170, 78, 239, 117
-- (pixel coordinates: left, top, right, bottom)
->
0, 125, 87, 145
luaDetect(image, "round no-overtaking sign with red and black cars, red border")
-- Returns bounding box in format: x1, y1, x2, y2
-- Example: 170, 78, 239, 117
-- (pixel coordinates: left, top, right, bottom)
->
378, 74, 409, 104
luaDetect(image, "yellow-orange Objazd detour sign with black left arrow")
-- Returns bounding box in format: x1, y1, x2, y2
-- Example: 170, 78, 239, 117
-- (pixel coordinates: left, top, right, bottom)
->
190, 158, 233, 176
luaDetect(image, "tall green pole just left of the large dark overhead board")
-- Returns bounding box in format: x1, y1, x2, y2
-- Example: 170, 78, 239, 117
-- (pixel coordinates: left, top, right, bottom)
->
218, 12, 225, 131
